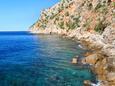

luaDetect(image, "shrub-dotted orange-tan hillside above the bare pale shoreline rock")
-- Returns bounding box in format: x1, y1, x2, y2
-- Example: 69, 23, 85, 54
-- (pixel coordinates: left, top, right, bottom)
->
31, 0, 115, 33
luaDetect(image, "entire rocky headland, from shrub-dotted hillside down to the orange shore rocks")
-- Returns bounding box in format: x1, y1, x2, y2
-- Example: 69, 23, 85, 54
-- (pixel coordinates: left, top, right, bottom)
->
30, 0, 115, 86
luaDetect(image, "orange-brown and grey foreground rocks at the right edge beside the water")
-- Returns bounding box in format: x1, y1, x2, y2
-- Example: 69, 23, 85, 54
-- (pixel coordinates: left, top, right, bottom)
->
83, 26, 115, 86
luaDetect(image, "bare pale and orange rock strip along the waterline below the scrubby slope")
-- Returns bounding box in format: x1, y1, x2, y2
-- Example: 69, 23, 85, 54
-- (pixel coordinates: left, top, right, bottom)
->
30, 28, 115, 86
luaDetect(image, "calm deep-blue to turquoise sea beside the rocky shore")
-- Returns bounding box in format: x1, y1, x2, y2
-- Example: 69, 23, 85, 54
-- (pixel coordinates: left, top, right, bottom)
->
0, 32, 95, 86
